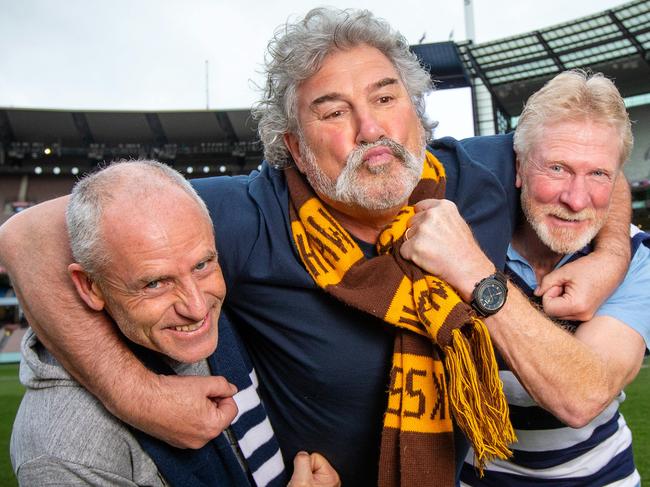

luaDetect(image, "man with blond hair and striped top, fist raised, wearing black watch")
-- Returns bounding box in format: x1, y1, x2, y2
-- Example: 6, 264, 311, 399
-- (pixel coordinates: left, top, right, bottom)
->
403, 71, 650, 486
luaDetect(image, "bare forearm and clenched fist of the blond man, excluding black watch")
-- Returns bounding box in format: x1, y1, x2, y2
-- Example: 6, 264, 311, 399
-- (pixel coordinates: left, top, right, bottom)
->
400, 198, 643, 426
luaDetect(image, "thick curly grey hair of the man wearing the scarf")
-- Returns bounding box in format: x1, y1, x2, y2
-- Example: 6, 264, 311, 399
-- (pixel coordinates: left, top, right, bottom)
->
252, 8, 436, 168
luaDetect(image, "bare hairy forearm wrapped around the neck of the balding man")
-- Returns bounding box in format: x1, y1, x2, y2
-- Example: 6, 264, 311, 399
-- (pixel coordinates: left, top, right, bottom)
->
0, 198, 151, 412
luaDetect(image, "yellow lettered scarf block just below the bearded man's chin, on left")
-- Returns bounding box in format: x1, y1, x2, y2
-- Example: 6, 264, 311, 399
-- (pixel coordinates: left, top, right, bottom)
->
291, 198, 363, 287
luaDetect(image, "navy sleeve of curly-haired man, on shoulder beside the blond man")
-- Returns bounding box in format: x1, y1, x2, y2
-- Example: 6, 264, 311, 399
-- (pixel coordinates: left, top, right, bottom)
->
432, 135, 519, 268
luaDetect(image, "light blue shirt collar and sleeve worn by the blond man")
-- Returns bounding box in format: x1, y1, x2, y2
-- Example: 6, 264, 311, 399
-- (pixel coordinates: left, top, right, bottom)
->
506, 227, 650, 347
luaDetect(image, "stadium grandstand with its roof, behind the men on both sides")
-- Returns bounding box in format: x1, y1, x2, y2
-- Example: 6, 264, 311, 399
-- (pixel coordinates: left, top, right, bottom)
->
0, 0, 650, 228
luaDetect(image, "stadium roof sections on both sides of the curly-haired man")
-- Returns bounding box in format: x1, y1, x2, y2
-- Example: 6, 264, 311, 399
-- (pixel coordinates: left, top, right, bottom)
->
0, 0, 650, 151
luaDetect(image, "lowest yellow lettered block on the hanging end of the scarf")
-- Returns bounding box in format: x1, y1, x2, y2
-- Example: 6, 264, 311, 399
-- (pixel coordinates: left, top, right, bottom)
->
384, 353, 453, 433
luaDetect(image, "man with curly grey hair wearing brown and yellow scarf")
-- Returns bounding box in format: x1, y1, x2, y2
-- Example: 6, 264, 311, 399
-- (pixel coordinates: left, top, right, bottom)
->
0, 5, 627, 486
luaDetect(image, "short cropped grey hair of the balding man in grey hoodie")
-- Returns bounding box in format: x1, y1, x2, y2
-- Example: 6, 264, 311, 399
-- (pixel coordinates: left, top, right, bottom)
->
66, 160, 210, 280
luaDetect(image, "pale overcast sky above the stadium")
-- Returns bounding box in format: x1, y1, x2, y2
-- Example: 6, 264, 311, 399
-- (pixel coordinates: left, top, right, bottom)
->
0, 0, 624, 137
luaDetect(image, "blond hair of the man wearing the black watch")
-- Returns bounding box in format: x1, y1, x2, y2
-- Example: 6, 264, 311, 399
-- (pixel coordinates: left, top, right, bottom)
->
514, 69, 634, 164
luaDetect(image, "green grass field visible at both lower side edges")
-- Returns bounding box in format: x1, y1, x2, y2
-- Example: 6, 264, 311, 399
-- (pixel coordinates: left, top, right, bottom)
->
0, 358, 650, 486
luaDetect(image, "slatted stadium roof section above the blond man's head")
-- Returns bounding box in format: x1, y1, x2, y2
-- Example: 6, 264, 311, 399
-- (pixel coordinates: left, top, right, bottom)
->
412, 0, 650, 116
